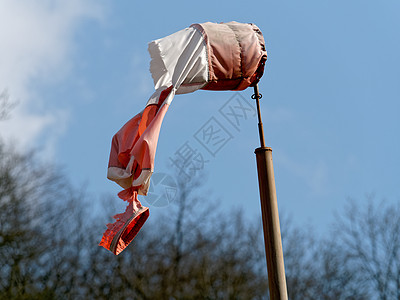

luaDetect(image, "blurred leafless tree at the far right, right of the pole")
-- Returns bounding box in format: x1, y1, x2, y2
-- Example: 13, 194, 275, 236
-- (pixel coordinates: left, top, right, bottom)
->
335, 197, 400, 300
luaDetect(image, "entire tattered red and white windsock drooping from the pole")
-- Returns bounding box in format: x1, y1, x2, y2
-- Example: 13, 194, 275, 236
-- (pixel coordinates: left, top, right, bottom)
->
100, 22, 267, 255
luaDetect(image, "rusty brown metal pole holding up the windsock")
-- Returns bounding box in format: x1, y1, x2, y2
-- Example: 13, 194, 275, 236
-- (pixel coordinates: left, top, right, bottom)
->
252, 85, 288, 300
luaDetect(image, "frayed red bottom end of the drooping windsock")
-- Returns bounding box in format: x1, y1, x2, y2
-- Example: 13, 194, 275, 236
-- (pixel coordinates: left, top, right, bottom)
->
99, 188, 149, 255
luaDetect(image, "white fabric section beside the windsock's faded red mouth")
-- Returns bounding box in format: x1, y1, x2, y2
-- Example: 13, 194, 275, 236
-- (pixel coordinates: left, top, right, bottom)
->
147, 27, 208, 105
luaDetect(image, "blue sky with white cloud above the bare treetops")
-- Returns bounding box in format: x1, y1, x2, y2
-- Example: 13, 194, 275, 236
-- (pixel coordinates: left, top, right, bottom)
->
0, 0, 400, 234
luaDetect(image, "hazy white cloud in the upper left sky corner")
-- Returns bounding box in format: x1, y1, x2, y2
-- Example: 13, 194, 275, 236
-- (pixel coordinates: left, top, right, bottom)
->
0, 0, 103, 155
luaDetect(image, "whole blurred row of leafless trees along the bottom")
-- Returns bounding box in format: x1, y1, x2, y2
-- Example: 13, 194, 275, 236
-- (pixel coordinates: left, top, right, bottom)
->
0, 138, 400, 300
